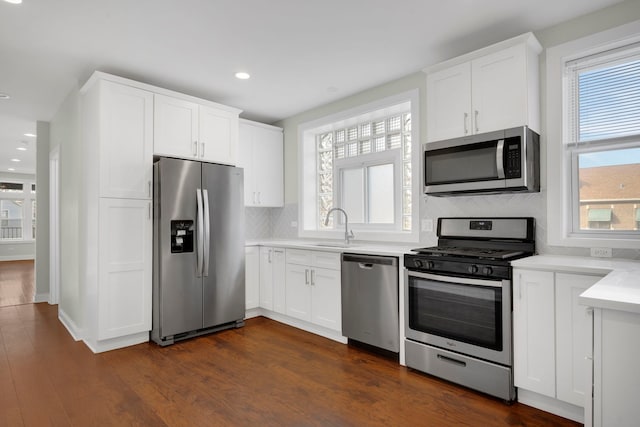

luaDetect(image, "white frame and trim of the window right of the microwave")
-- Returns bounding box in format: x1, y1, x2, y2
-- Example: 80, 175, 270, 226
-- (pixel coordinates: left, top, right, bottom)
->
542, 21, 640, 248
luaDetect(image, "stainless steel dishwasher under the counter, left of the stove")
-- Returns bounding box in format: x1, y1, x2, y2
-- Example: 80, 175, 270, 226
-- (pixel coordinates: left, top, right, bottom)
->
342, 253, 400, 353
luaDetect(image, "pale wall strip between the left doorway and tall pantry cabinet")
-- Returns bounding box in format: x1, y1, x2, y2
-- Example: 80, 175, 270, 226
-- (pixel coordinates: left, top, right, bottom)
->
47, 89, 83, 336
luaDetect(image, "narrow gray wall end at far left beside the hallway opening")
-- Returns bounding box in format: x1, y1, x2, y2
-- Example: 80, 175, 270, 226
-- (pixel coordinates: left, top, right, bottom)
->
35, 122, 49, 301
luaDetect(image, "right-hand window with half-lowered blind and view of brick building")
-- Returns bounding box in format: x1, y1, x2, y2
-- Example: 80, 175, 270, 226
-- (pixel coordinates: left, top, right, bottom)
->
565, 44, 640, 233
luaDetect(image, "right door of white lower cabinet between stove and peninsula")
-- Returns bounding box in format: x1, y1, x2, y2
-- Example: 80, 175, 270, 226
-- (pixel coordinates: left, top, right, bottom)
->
556, 273, 602, 407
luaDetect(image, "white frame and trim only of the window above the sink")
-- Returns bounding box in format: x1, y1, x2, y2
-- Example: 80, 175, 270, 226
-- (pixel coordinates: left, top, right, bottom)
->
298, 89, 421, 242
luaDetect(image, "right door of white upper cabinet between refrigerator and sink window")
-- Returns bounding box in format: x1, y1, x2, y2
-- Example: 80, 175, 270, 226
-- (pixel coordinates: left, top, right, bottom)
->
253, 127, 284, 207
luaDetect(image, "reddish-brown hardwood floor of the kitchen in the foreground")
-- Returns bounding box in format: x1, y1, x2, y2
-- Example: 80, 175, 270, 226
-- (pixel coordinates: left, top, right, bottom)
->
0, 303, 577, 427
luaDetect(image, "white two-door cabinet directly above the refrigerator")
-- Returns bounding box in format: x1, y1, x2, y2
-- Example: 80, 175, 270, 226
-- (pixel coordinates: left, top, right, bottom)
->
153, 94, 238, 165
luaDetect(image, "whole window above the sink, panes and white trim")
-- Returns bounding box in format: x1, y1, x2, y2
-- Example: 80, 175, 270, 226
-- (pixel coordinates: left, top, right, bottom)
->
299, 91, 419, 241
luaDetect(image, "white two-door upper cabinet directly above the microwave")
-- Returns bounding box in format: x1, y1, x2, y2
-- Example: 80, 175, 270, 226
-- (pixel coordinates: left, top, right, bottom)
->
425, 33, 542, 142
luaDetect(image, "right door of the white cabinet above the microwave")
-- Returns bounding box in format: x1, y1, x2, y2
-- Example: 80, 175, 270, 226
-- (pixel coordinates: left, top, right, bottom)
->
471, 46, 528, 133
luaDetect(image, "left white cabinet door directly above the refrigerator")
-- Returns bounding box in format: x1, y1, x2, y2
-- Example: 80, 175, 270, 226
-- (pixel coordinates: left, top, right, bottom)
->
153, 94, 199, 159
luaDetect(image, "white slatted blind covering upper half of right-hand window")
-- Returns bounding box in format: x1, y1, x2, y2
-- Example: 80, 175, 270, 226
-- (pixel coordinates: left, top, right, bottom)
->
566, 43, 640, 144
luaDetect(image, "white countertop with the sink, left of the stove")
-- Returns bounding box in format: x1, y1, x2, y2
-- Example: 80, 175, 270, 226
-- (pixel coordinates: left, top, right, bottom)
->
245, 239, 420, 257
